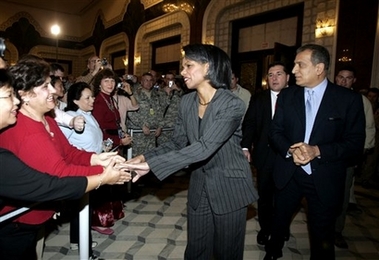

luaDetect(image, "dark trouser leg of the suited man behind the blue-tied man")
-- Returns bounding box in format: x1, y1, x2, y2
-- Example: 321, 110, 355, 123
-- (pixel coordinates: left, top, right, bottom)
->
257, 168, 275, 235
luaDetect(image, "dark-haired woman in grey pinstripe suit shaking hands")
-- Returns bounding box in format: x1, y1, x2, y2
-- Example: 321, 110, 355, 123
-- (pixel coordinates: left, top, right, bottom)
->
127, 44, 258, 260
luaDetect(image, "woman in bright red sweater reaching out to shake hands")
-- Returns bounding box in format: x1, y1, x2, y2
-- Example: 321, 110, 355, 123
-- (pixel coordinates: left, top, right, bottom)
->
0, 57, 124, 259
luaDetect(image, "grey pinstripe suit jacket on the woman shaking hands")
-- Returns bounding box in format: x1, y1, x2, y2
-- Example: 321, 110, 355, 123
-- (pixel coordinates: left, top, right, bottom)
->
144, 89, 258, 214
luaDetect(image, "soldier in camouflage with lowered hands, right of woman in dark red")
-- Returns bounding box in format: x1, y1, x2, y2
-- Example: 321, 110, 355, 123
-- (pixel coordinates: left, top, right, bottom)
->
127, 73, 164, 157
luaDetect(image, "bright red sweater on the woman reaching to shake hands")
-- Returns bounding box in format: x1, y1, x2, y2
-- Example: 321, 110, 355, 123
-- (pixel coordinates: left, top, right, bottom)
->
0, 113, 103, 224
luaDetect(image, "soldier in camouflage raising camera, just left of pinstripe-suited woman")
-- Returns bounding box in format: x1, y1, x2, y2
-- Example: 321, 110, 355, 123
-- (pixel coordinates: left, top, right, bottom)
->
158, 72, 183, 145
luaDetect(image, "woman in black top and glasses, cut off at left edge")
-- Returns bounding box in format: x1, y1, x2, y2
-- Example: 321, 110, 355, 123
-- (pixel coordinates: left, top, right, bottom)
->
0, 69, 130, 259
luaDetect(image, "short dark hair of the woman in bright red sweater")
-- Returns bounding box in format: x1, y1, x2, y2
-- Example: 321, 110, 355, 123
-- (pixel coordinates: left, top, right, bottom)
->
9, 55, 50, 98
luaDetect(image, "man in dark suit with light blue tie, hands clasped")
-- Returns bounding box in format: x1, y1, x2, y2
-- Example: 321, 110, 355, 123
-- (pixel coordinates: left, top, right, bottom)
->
264, 44, 365, 260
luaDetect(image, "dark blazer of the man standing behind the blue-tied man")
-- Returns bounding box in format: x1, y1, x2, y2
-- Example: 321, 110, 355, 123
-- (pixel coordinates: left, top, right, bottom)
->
241, 89, 275, 171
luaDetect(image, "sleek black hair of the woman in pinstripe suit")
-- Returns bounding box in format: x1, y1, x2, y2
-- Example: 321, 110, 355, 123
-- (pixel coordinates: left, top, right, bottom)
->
183, 44, 232, 89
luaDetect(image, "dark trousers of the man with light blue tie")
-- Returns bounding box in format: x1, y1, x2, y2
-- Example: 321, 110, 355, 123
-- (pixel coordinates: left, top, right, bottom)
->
265, 167, 339, 260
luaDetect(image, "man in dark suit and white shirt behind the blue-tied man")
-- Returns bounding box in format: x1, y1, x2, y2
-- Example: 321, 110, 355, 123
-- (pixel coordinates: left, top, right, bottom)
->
241, 61, 290, 245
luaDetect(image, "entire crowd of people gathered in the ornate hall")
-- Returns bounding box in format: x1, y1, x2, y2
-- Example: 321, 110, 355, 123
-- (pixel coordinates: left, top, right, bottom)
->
0, 41, 379, 260
